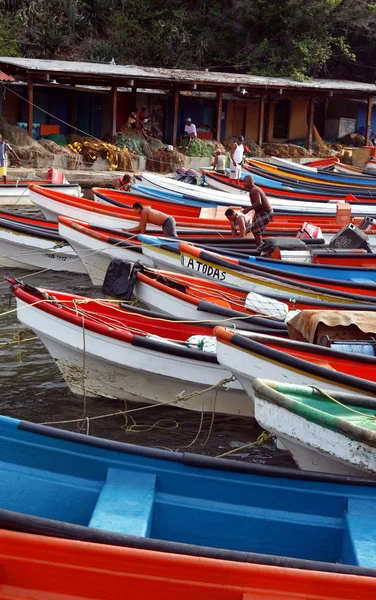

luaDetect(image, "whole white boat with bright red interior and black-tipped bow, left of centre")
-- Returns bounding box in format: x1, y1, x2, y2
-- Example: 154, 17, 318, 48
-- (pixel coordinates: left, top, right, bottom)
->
12, 280, 253, 416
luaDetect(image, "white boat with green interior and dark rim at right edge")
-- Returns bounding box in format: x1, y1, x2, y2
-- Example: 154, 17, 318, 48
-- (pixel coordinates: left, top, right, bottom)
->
253, 379, 376, 476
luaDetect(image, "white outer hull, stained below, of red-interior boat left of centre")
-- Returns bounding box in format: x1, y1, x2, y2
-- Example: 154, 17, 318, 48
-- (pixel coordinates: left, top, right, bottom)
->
17, 298, 253, 416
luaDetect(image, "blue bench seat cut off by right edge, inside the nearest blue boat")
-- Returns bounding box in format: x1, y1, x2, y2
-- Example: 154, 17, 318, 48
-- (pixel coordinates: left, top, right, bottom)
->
341, 498, 376, 567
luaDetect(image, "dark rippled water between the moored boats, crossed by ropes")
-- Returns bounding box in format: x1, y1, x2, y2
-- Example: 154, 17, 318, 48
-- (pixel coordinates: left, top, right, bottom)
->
0, 213, 294, 466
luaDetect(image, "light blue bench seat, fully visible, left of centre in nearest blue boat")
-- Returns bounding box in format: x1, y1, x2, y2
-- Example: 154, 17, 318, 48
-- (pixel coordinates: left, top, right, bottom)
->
89, 468, 156, 537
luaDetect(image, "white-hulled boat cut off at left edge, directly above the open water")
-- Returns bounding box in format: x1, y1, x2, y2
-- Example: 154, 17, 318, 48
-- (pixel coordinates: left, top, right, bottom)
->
0, 213, 86, 273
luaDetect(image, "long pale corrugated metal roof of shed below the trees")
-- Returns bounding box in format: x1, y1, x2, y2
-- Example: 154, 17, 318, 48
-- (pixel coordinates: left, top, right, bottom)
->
0, 56, 376, 95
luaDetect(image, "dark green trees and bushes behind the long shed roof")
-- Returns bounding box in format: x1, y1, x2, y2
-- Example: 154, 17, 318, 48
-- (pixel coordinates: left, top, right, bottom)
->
0, 0, 376, 82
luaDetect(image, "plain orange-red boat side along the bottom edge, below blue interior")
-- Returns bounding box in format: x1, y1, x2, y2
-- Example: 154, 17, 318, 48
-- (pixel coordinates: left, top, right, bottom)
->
0, 530, 376, 600
